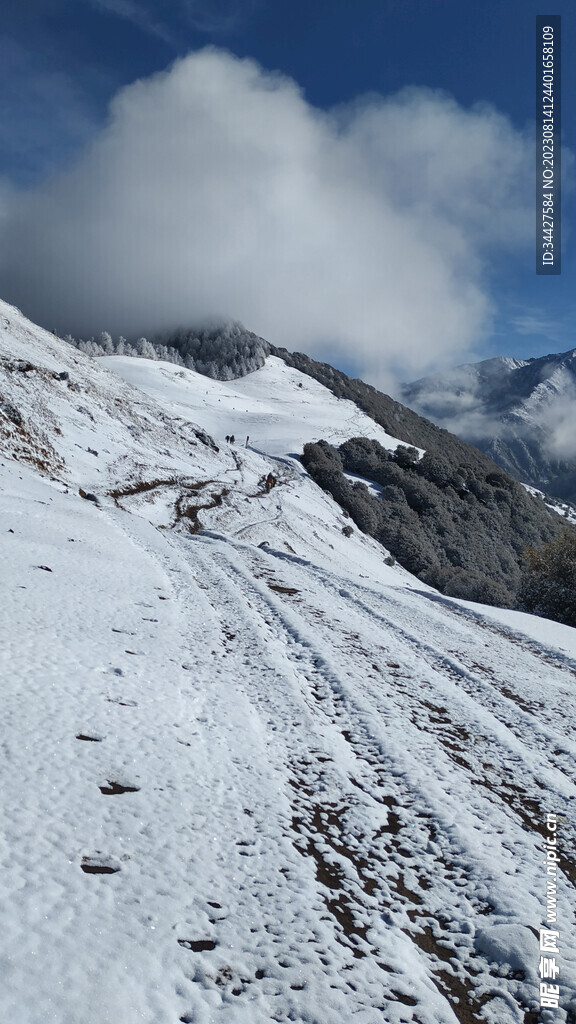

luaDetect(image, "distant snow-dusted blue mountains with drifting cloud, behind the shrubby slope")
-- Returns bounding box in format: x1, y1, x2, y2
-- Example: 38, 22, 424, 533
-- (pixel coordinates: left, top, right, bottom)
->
402, 349, 576, 502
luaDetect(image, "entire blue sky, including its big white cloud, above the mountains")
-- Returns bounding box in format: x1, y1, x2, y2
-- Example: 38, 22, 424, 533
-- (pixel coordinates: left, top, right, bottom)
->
0, 0, 576, 383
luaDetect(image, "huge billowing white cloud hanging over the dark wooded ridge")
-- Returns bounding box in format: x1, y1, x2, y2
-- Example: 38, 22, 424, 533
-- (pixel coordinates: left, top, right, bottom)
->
0, 49, 533, 384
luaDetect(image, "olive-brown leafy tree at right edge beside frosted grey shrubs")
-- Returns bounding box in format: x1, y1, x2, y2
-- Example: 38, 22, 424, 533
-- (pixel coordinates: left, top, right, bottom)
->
512, 525, 576, 626
